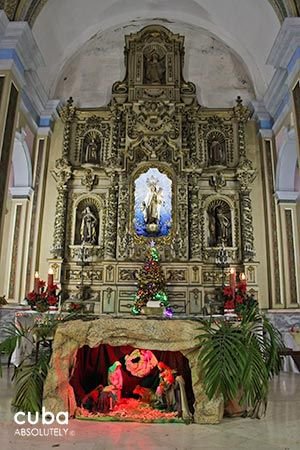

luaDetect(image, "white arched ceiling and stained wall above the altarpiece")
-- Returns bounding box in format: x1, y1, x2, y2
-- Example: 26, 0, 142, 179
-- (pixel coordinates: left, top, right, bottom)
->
0, 0, 292, 106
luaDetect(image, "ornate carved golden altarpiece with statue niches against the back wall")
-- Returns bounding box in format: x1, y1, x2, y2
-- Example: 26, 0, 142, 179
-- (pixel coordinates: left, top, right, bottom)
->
49, 25, 257, 314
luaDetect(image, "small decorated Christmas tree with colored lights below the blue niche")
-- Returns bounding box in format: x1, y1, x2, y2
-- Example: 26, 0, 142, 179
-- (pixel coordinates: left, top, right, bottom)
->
131, 242, 172, 317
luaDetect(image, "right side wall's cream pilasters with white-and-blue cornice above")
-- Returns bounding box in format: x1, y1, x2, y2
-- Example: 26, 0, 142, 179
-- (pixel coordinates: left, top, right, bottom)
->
253, 17, 300, 308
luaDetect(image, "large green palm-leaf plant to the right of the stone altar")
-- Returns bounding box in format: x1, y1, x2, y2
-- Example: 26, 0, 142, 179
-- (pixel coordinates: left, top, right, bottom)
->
198, 303, 283, 417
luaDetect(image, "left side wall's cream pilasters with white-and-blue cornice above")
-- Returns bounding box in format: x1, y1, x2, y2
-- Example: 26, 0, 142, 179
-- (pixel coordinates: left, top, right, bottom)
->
0, 11, 59, 301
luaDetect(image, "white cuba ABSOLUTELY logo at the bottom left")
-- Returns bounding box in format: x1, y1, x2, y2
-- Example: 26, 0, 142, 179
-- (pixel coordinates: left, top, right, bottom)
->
14, 406, 69, 437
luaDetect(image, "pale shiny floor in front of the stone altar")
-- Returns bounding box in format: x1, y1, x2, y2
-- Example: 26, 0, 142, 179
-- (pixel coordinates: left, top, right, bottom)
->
0, 370, 300, 450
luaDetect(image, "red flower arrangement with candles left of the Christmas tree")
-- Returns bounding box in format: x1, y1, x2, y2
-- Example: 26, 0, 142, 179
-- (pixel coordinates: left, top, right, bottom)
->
26, 279, 59, 312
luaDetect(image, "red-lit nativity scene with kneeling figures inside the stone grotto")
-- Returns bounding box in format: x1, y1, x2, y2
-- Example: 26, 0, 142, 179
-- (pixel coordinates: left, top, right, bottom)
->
74, 346, 194, 422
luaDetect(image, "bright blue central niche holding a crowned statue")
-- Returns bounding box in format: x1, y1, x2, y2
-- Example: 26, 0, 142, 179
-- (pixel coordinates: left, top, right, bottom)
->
134, 168, 172, 237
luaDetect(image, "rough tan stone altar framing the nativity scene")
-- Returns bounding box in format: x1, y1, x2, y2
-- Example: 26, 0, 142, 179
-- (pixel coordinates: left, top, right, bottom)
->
43, 315, 224, 424
